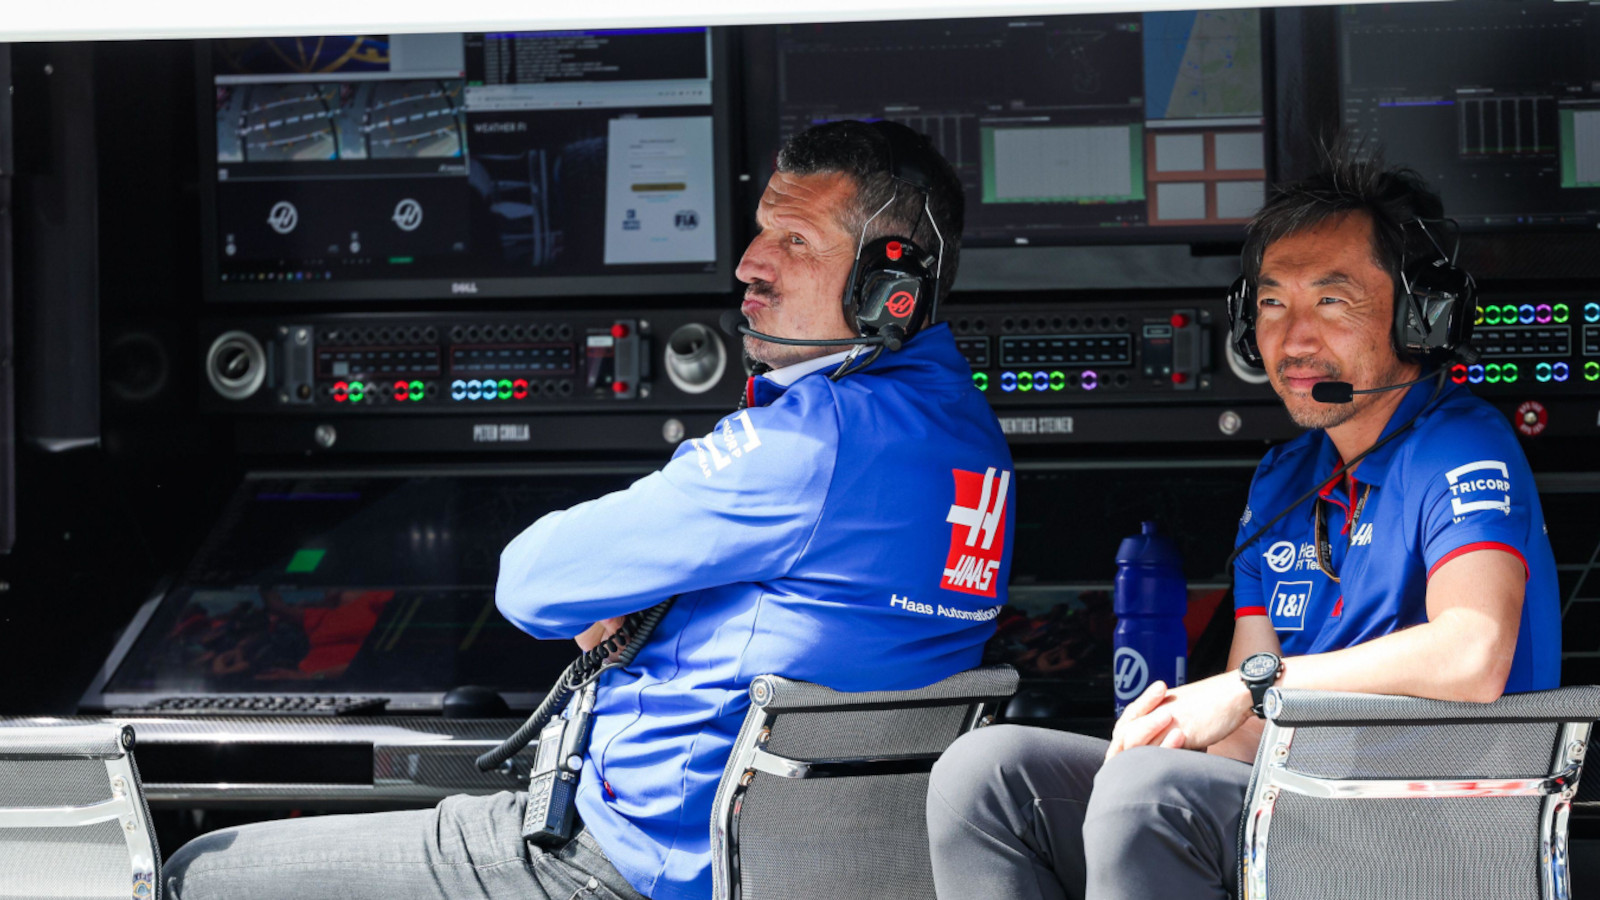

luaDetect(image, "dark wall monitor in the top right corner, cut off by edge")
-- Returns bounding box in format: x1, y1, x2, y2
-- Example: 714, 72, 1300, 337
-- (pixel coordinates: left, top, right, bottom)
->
1338, 0, 1600, 232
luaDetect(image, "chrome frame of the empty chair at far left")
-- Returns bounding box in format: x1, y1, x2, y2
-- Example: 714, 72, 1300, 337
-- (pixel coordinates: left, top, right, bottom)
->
0, 721, 162, 900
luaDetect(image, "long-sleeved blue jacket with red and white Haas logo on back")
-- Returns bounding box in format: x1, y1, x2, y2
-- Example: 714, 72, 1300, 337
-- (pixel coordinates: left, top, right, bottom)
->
496, 325, 1016, 900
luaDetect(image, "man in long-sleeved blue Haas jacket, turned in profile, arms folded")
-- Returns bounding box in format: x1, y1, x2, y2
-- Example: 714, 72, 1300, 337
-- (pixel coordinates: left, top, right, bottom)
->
168, 122, 1016, 900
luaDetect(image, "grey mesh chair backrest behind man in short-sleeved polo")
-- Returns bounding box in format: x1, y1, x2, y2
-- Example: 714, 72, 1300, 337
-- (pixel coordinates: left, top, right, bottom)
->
1238, 687, 1600, 900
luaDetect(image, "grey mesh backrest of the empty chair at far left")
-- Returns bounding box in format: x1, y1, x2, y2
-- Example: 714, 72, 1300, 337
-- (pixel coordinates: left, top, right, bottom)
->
0, 719, 162, 900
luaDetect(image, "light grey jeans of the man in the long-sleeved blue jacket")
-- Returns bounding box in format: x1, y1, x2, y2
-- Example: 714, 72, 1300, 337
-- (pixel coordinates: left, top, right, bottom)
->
162, 793, 645, 900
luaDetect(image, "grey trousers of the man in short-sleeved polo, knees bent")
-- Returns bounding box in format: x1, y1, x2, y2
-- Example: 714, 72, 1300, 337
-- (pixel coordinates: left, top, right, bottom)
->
928, 725, 1250, 900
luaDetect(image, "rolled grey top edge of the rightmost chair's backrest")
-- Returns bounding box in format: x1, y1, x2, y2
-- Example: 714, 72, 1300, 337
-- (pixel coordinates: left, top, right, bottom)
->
1264, 685, 1600, 729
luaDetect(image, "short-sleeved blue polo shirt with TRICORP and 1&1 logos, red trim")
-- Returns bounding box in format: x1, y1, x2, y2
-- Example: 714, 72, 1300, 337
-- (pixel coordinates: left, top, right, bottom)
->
1234, 374, 1562, 693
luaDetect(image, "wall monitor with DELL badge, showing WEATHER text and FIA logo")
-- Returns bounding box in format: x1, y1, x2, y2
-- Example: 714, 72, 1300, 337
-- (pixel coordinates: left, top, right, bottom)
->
200, 27, 733, 301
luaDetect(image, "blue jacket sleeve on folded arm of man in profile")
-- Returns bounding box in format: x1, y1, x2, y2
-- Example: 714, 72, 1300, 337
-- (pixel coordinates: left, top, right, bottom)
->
494, 410, 837, 639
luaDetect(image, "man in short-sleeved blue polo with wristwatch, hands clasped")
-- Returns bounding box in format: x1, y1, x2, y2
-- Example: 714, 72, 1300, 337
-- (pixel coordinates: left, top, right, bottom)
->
928, 154, 1560, 900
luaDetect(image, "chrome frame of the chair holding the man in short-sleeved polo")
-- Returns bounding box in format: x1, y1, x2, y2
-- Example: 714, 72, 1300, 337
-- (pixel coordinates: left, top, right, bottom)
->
1238, 687, 1600, 900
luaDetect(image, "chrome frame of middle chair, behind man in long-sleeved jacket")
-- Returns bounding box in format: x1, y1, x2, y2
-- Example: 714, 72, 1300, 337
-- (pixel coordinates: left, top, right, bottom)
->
710, 666, 1018, 900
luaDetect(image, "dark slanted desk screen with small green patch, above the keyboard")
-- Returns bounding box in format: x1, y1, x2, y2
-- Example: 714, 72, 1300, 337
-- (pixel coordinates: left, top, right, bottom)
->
106, 472, 643, 695
